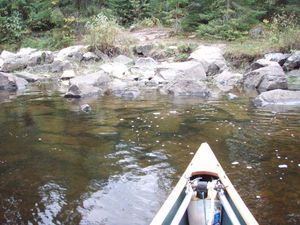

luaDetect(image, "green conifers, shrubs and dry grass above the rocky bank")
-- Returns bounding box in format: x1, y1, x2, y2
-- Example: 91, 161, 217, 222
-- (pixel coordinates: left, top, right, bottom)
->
0, 0, 300, 64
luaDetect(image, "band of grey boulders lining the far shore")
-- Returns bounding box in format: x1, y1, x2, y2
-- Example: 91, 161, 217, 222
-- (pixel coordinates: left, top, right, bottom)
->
0, 45, 300, 107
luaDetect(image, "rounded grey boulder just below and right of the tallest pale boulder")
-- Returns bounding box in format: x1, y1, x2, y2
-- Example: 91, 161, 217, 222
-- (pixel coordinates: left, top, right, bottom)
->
214, 70, 243, 91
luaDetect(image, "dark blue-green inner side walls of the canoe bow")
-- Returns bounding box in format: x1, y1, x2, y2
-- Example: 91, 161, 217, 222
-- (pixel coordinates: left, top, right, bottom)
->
163, 178, 246, 225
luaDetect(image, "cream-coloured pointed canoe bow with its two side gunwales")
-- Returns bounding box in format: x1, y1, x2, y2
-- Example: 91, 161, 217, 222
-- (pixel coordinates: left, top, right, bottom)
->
151, 143, 258, 225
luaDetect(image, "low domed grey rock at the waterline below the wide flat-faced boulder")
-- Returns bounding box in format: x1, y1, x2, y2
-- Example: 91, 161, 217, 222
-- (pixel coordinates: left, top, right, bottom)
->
163, 80, 211, 98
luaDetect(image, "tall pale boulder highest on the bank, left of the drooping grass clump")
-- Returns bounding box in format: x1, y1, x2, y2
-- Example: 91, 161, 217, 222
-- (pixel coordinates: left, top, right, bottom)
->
189, 45, 226, 75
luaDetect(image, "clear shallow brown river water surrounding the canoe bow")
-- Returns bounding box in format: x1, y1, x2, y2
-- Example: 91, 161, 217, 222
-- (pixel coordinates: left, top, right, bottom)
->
0, 93, 300, 225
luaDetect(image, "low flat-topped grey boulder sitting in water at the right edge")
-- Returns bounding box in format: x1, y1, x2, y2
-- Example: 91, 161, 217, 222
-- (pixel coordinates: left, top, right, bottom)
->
254, 89, 300, 106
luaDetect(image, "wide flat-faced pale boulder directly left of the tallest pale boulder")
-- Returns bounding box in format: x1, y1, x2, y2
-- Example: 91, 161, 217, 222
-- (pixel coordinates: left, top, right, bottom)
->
156, 61, 207, 81
